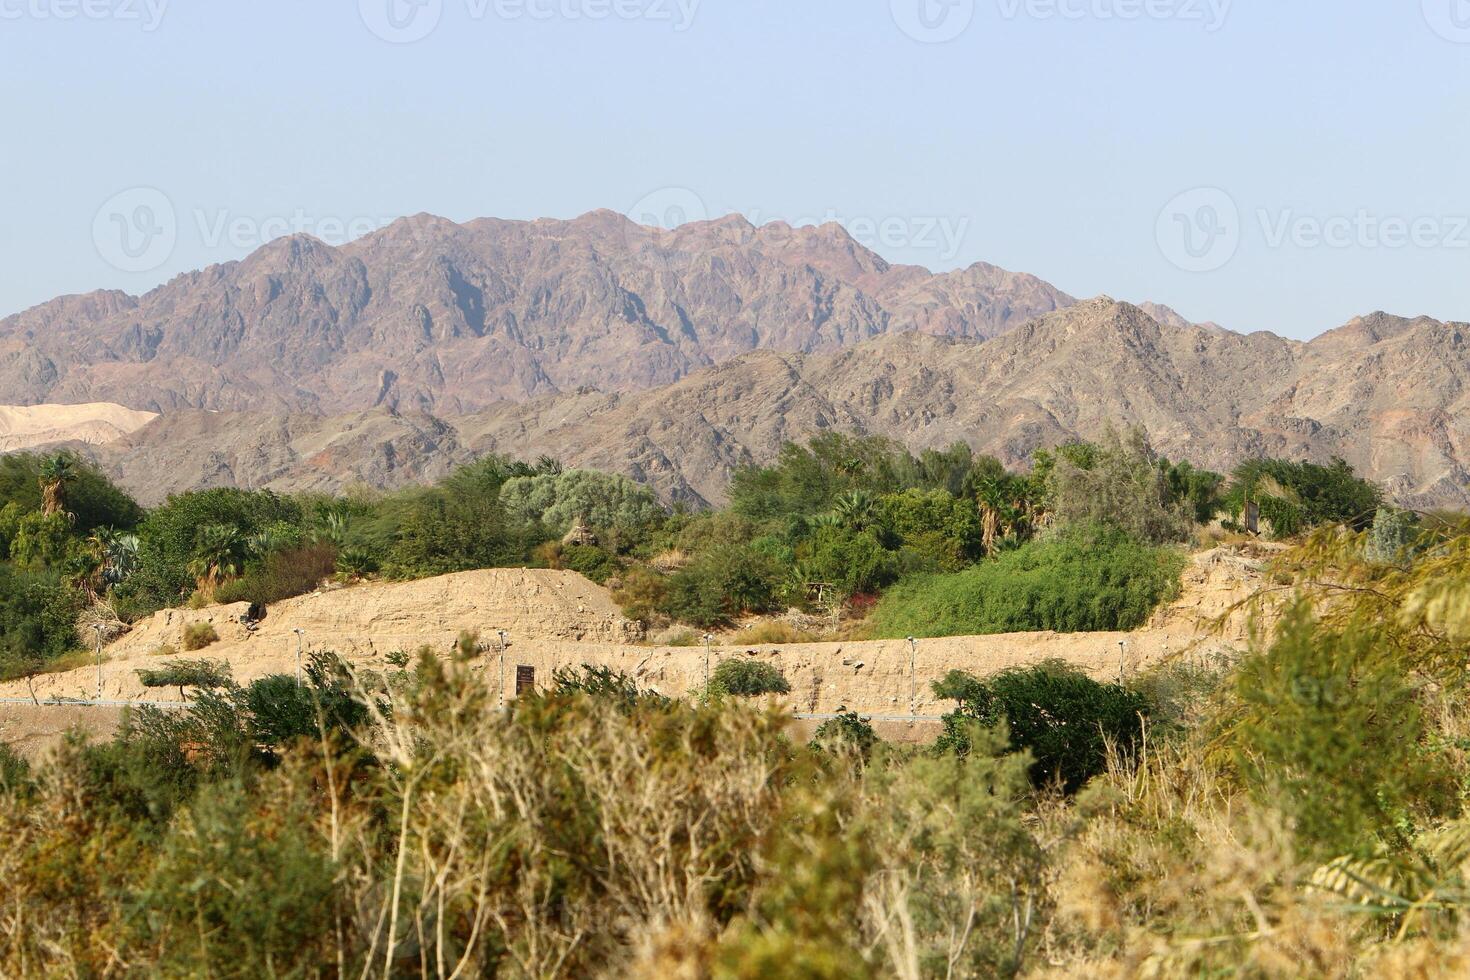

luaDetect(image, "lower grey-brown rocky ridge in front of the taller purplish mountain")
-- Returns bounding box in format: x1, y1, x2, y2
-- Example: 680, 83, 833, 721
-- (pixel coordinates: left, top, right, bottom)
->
88, 301, 1470, 507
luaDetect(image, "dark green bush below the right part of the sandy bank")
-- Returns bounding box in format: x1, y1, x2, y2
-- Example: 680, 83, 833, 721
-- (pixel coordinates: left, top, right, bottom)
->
933, 661, 1150, 793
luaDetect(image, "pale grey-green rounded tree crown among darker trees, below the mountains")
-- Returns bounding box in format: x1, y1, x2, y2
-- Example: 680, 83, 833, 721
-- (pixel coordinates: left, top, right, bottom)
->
500, 470, 664, 536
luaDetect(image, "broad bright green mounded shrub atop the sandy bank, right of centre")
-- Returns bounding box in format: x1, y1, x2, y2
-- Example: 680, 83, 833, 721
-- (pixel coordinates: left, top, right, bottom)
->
870, 525, 1183, 638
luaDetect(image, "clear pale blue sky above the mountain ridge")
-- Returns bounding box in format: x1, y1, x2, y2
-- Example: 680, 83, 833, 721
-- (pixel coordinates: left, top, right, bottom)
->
0, 0, 1470, 338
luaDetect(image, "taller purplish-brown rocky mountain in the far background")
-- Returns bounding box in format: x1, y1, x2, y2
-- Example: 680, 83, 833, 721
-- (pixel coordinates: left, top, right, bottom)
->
0, 212, 1073, 416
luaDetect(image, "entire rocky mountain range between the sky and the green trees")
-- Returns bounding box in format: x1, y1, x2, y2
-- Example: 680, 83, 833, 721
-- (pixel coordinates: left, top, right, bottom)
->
0, 212, 1470, 507
